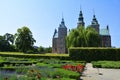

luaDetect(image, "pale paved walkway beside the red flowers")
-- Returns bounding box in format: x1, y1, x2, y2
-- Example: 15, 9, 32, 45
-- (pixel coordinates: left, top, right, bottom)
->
81, 63, 120, 80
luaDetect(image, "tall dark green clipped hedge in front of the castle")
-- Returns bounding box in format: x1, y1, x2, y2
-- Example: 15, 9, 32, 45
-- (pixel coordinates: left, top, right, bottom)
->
69, 47, 120, 61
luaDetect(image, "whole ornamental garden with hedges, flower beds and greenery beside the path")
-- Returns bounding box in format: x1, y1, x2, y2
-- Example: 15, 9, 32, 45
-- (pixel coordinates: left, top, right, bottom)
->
0, 48, 120, 80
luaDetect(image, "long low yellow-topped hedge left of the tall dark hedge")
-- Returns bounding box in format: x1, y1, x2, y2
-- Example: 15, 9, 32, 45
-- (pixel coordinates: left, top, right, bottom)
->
0, 52, 69, 60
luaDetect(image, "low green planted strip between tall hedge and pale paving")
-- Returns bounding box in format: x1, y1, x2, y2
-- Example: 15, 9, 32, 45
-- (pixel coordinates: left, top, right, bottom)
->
92, 61, 120, 69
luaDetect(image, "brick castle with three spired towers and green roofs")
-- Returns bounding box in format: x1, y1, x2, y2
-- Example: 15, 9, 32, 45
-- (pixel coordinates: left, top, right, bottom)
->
52, 11, 111, 53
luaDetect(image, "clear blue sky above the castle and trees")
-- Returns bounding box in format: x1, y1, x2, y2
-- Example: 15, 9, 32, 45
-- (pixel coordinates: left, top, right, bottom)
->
0, 0, 120, 47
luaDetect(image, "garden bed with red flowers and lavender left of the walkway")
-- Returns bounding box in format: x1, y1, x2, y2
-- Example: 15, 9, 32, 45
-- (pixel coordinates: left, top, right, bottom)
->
0, 57, 85, 80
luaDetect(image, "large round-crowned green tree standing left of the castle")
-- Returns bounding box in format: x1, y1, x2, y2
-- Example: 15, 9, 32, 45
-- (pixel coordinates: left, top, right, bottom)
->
15, 26, 36, 53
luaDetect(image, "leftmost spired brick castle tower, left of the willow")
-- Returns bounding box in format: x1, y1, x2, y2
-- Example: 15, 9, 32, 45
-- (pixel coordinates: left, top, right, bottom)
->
58, 18, 67, 53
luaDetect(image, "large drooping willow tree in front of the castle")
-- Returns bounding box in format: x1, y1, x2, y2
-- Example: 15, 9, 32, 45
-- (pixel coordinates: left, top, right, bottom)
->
66, 26, 100, 48
